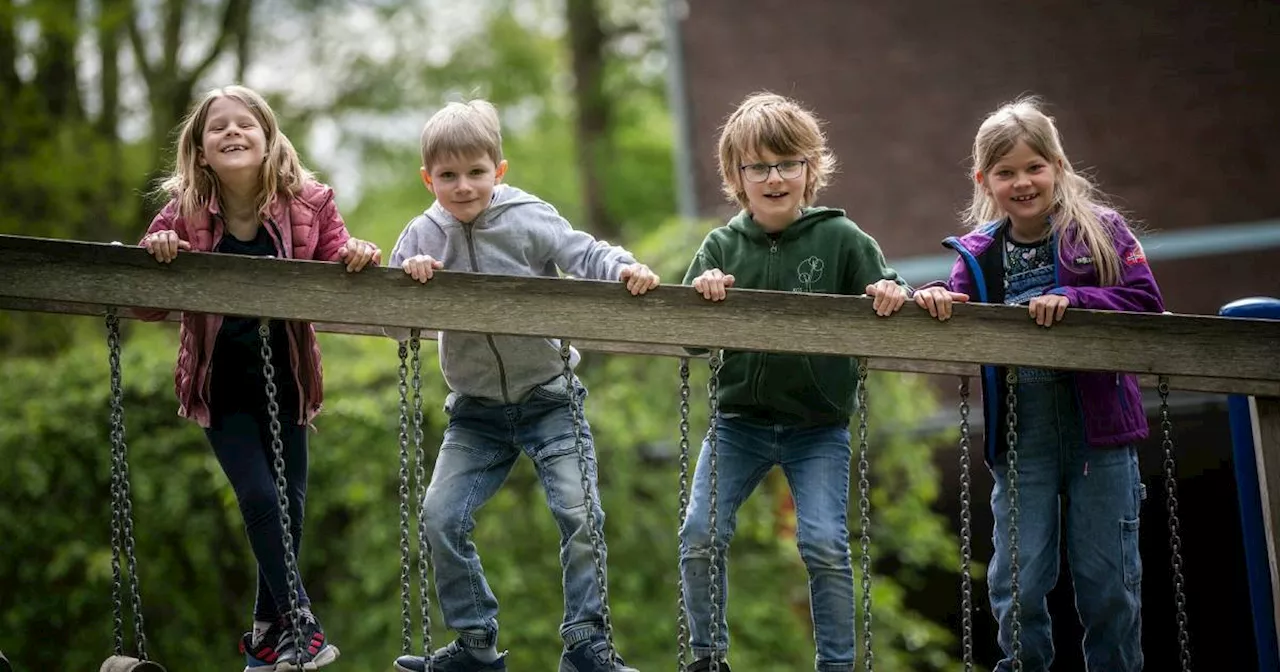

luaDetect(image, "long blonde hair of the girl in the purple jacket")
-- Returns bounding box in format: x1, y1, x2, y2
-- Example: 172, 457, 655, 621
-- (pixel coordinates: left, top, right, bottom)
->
964, 97, 1120, 285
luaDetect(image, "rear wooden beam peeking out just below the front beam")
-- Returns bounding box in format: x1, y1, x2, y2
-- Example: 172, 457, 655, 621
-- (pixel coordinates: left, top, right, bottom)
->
0, 297, 1280, 397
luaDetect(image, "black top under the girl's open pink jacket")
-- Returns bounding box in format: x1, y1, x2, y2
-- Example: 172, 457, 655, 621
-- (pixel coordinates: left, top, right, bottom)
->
210, 225, 298, 421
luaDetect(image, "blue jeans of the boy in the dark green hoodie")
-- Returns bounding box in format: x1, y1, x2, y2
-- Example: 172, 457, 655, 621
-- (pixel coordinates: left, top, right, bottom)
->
680, 417, 855, 672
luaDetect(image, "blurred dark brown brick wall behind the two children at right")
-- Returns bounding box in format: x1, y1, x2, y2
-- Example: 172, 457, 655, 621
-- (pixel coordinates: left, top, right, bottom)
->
684, 0, 1280, 312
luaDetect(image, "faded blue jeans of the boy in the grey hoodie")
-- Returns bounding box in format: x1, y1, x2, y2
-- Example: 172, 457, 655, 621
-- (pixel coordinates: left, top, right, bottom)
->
424, 378, 604, 648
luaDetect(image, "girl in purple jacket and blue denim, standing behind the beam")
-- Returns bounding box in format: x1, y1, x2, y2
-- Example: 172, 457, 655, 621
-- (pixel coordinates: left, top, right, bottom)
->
915, 99, 1164, 672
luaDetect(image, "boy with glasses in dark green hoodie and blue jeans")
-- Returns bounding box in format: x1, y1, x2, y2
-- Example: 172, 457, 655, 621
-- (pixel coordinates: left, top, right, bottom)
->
680, 93, 910, 672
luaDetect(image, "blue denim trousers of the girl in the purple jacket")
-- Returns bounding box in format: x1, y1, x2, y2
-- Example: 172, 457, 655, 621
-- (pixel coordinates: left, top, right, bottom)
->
988, 376, 1146, 672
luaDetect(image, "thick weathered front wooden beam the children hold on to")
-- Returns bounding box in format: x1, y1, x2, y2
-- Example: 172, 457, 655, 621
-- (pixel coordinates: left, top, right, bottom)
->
0, 236, 1280, 392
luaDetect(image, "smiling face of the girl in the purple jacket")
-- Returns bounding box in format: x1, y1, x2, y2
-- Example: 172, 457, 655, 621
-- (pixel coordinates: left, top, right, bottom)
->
974, 140, 1057, 234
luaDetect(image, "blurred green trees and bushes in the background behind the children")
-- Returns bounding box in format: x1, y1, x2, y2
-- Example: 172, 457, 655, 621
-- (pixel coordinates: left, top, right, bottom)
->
0, 0, 957, 671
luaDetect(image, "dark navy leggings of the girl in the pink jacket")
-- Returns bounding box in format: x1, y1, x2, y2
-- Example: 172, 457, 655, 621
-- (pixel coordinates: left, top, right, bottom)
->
205, 412, 311, 621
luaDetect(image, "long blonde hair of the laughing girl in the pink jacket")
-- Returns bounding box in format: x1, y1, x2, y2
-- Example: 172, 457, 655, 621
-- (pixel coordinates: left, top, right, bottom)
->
160, 86, 315, 216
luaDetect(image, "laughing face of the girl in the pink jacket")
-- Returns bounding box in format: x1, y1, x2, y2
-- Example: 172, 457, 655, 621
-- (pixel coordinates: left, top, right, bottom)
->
200, 97, 266, 182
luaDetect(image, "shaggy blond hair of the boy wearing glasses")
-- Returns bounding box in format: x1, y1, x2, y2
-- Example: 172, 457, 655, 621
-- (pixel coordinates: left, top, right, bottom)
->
719, 92, 836, 209
